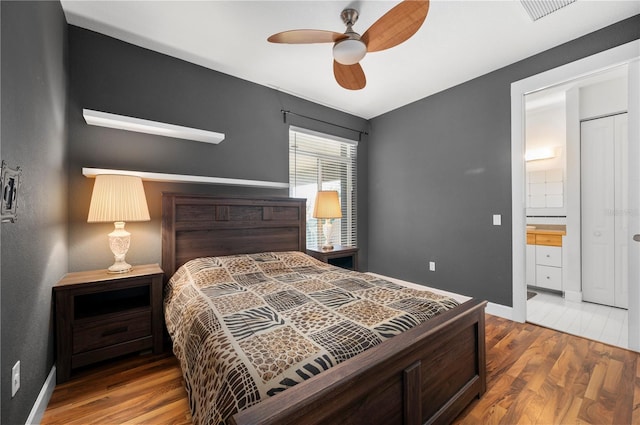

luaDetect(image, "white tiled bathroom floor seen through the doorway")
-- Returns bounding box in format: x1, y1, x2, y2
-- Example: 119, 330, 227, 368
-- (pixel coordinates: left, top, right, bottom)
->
527, 291, 629, 348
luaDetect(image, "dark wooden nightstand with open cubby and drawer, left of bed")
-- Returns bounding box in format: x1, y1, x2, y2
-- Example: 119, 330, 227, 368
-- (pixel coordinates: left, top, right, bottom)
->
53, 264, 164, 383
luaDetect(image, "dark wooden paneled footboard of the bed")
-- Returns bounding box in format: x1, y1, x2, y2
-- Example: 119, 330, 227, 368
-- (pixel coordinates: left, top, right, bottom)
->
230, 300, 486, 425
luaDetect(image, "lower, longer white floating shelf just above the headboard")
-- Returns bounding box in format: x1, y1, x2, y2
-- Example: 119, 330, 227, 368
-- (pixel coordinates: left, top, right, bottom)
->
82, 168, 289, 189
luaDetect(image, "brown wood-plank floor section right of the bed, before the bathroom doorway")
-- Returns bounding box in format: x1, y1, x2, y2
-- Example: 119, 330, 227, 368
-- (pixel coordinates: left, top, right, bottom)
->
454, 315, 640, 425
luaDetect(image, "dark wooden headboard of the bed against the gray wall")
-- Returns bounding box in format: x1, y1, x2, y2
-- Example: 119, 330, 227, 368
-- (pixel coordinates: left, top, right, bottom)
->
162, 193, 307, 279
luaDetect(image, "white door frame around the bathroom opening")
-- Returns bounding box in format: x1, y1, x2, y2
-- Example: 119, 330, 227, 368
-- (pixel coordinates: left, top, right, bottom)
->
511, 40, 640, 351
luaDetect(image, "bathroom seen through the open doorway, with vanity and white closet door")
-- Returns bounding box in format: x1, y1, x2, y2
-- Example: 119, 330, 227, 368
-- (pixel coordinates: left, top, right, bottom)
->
525, 65, 628, 348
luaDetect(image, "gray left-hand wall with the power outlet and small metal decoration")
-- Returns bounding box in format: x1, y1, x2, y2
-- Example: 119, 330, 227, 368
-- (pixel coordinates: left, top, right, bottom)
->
0, 1, 67, 424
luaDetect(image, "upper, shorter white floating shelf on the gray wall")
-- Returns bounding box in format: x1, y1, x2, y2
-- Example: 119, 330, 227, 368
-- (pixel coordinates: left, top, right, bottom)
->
82, 109, 224, 145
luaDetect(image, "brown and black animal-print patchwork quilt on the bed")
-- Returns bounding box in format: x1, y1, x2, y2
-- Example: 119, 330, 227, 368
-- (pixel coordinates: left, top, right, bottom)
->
165, 252, 458, 424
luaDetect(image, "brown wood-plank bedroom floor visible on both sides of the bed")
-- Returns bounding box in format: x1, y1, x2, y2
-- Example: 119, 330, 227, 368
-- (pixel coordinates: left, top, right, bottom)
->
42, 315, 640, 425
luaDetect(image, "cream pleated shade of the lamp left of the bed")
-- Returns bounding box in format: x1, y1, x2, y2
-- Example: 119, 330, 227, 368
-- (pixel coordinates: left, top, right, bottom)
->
87, 174, 150, 223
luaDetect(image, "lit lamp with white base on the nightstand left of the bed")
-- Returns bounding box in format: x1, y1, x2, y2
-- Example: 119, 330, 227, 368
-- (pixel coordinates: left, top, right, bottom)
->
87, 174, 150, 273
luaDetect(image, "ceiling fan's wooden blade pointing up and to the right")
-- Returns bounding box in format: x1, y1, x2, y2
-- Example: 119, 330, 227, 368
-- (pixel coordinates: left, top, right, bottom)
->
361, 0, 429, 52
